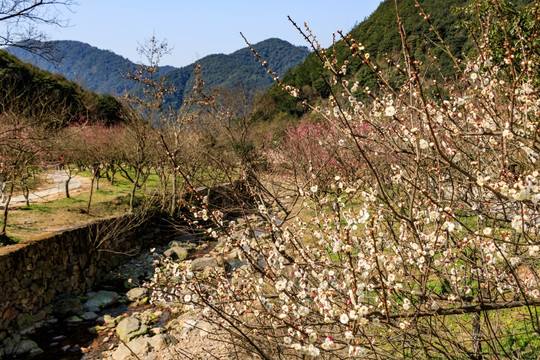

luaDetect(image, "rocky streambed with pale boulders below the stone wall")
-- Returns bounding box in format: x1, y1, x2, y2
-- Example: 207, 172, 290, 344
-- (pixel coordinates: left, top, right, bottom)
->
0, 217, 264, 360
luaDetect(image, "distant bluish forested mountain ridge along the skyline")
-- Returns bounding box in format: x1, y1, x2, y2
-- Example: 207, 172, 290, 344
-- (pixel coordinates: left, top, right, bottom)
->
9, 39, 309, 107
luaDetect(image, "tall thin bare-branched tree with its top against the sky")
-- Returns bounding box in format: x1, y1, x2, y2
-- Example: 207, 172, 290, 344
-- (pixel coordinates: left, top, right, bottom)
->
125, 37, 213, 215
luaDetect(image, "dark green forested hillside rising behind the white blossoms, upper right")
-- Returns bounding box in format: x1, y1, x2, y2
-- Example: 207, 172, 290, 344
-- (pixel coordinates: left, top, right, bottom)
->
256, 0, 532, 119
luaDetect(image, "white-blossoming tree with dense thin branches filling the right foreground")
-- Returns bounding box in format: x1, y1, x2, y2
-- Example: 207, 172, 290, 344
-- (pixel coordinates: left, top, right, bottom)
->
148, 2, 540, 359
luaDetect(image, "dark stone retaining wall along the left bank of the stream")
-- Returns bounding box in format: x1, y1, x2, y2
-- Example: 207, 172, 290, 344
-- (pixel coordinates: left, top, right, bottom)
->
0, 215, 155, 336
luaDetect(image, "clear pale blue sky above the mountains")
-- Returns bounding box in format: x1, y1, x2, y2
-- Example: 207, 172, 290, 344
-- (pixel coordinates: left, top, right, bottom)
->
43, 0, 381, 67
